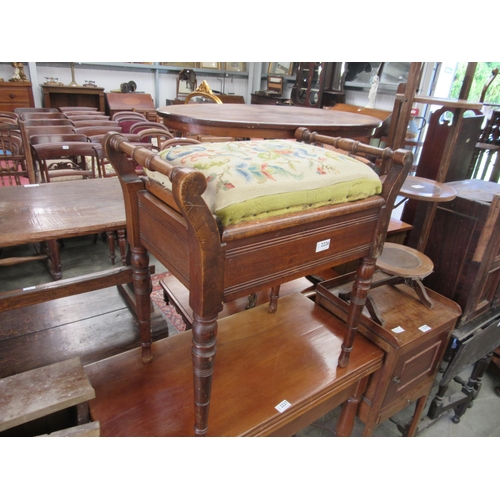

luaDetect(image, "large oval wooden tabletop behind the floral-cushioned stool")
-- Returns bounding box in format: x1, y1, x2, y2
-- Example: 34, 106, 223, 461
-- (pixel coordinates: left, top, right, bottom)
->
157, 104, 382, 139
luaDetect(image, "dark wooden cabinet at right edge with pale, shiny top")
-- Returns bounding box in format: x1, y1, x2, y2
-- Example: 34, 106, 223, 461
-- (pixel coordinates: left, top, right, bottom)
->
415, 179, 500, 325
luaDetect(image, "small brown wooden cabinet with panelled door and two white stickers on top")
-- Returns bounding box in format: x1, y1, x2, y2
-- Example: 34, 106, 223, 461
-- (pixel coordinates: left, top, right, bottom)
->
316, 271, 461, 435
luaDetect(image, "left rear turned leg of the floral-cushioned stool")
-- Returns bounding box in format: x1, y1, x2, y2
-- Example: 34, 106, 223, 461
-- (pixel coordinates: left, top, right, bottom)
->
131, 247, 153, 363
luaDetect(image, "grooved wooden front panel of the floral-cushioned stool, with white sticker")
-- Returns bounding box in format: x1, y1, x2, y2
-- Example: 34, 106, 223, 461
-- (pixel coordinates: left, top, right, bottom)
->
224, 205, 378, 300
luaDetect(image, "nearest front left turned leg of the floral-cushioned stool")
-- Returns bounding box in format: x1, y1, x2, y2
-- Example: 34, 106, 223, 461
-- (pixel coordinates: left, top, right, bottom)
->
191, 313, 218, 436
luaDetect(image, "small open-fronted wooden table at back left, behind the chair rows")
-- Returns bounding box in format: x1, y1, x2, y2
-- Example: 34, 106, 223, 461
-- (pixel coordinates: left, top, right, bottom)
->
41, 85, 105, 111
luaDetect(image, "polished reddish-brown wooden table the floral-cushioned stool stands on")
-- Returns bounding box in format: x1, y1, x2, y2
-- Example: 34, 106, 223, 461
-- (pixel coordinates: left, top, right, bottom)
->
85, 293, 383, 436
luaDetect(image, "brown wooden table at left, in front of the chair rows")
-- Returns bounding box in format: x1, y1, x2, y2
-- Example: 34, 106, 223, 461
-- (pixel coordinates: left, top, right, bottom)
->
0, 178, 126, 280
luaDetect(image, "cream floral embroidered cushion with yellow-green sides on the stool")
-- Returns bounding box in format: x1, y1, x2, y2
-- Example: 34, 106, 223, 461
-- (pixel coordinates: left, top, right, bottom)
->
146, 140, 382, 226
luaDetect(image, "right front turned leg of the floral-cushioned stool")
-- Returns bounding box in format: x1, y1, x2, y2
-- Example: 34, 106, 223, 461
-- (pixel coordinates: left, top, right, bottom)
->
338, 257, 376, 368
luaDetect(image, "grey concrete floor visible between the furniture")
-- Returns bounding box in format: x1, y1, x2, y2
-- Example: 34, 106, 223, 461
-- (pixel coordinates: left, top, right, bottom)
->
0, 236, 500, 437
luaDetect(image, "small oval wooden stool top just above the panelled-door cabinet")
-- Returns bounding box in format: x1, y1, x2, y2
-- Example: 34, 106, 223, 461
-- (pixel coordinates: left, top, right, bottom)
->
377, 242, 434, 279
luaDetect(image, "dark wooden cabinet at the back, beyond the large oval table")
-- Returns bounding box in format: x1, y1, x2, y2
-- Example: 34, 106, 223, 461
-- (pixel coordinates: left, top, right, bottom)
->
291, 62, 345, 108
